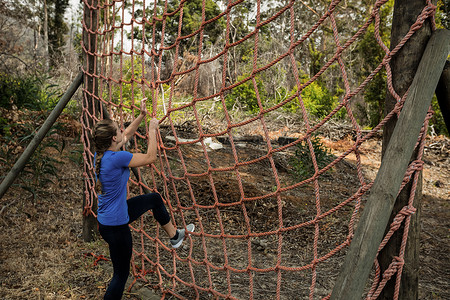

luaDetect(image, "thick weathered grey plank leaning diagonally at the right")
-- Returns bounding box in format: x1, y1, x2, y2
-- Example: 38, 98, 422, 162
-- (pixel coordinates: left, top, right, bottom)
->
331, 30, 450, 300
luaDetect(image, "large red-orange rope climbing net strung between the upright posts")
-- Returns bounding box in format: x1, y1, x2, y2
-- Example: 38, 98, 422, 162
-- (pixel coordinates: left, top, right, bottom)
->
81, 0, 435, 299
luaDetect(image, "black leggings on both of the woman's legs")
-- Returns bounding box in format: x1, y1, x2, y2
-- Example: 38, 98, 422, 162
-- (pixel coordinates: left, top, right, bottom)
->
99, 193, 170, 300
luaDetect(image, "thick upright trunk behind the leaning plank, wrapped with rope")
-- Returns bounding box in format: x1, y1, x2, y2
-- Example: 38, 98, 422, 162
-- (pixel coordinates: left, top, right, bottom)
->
378, 0, 435, 300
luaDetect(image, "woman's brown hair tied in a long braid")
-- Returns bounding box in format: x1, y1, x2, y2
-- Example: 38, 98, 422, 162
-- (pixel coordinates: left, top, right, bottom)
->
93, 119, 117, 192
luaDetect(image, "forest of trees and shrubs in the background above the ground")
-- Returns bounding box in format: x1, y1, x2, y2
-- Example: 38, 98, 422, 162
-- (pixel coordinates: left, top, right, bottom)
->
0, 0, 450, 136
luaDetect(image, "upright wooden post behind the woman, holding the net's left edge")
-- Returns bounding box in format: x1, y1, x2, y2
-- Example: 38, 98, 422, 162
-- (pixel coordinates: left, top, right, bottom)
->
82, 0, 100, 242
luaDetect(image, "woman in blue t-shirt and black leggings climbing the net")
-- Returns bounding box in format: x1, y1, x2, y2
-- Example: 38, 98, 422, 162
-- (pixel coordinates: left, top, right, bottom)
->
93, 98, 195, 299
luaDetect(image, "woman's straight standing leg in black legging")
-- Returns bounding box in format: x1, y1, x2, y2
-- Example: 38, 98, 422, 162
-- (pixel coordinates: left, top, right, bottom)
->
99, 224, 133, 300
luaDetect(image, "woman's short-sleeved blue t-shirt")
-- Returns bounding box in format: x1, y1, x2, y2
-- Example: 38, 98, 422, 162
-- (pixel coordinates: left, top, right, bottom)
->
97, 150, 133, 226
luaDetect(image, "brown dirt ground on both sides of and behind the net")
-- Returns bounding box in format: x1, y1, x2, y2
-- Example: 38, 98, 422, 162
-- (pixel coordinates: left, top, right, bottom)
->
0, 118, 450, 299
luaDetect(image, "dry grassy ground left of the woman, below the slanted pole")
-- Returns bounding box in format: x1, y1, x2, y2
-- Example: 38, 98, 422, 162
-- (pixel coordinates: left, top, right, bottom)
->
0, 158, 110, 299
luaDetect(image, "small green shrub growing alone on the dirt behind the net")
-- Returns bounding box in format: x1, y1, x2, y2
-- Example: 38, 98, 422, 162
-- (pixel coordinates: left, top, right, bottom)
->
291, 136, 333, 180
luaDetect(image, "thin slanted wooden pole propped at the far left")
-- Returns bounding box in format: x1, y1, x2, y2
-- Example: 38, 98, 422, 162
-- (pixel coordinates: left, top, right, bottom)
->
0, 72, 83, 199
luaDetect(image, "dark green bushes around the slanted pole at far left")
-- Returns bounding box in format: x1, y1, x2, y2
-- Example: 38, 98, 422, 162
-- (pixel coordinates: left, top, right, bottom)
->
0, 70, 78, 196
